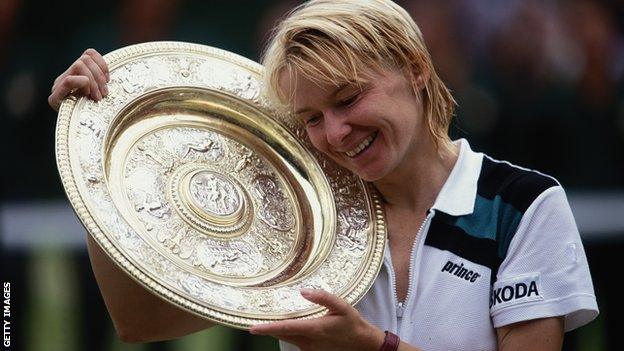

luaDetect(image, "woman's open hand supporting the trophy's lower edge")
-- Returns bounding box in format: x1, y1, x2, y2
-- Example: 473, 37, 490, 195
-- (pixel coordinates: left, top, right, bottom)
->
250, 289, 384, 351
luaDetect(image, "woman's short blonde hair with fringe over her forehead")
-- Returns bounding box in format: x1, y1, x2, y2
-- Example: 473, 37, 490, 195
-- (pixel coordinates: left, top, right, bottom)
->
262, 0, 455, 151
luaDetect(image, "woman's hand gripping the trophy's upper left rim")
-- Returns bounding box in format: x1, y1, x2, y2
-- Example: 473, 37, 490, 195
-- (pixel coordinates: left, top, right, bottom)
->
48, 49, 110, 111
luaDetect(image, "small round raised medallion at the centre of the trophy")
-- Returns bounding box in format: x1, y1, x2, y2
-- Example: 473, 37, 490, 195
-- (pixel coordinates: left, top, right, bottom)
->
169, 164, 252, 238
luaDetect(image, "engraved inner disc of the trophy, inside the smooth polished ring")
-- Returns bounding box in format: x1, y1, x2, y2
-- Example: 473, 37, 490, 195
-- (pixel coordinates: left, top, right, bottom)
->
112, 121, 302, 284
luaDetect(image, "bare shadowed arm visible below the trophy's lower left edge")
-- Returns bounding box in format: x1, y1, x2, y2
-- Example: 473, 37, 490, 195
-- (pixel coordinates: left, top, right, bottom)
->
87, 235, 213, 342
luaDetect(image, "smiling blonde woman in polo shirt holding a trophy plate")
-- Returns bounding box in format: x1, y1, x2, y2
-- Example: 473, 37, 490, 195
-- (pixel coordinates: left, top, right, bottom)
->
49, 0, 598, 350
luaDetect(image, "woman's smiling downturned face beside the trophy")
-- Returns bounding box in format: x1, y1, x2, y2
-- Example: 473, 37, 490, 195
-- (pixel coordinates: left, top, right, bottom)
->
281, 66, 431, 181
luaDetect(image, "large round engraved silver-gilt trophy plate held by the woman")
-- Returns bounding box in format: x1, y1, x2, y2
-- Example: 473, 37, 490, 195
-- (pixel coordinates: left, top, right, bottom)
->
56, 42, 386, 329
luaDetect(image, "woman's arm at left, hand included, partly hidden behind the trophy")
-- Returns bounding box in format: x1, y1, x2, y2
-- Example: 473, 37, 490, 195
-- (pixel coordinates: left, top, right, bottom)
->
48, 49, 212, 342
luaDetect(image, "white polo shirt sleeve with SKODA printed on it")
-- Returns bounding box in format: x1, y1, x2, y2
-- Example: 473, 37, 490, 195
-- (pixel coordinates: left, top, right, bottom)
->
490, 186, 598, 331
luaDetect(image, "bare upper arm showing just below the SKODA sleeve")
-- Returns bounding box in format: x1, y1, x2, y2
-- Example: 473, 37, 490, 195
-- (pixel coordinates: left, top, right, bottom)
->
496, 317, 563, 351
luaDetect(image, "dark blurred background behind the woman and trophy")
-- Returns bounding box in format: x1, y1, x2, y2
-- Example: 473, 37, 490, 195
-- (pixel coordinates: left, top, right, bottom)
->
0, 0, 624, 351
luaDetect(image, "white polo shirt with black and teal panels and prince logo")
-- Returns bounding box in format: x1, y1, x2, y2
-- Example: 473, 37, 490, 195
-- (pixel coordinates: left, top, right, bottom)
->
280, 139, 598, 351
